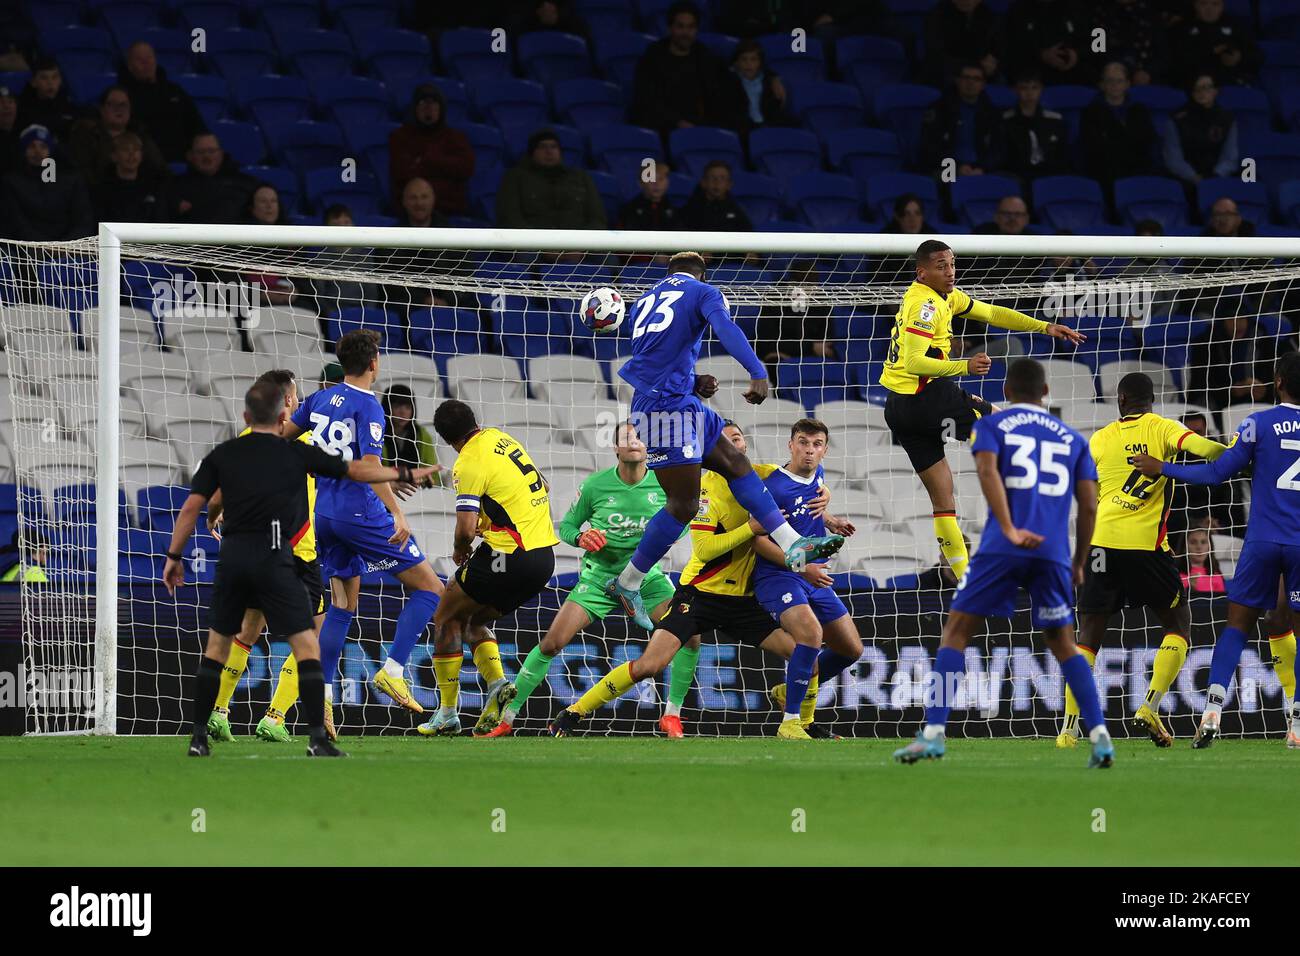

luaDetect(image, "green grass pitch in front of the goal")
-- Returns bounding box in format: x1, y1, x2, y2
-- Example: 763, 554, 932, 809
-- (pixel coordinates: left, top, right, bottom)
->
0, 737, 1300, 866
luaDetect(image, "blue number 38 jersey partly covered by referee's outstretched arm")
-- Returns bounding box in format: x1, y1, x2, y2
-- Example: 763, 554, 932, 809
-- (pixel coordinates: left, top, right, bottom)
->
294, 382, 389, 520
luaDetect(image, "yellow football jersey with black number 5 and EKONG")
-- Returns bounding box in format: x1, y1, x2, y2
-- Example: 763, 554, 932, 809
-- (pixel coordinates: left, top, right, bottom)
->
451, 428, 559, 554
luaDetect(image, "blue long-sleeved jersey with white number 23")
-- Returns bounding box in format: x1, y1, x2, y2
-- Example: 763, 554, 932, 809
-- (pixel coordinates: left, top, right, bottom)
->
619, 272, 767, 398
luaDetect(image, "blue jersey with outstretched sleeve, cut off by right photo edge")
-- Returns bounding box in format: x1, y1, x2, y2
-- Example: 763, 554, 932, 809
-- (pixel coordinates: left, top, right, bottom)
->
1165, 403, 1300, 545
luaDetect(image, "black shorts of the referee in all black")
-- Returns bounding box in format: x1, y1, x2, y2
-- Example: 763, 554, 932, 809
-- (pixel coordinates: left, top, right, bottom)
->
209, 535, 319, 637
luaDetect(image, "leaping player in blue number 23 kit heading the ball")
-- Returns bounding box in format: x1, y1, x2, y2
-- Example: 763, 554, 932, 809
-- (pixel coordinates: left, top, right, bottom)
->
608, 252, 844, 631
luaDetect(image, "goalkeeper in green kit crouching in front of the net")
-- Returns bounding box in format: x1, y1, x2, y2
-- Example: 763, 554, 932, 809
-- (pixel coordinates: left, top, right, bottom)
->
475, 424, 699, 737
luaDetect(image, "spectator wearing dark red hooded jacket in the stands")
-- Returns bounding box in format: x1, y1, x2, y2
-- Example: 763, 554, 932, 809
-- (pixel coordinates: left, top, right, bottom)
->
389, 83, 475, 216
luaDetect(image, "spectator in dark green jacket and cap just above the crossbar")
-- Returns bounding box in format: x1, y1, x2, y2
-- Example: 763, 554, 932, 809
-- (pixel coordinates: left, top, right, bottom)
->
497, 130, 605, 229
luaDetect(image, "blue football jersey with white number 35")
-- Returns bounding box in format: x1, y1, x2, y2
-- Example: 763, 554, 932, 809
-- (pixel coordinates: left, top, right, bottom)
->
971, 405, 1097, 564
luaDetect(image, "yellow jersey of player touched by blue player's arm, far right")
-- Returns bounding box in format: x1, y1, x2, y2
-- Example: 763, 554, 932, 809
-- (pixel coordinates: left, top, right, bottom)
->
1088, 412, 1197, 551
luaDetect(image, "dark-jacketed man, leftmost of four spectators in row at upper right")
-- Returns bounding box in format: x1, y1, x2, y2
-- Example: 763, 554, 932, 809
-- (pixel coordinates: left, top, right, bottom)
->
920, 60, 998, 176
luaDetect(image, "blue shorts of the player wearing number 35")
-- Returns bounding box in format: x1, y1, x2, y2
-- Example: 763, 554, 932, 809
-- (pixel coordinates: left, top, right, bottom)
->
953, 554, 1076, 627
